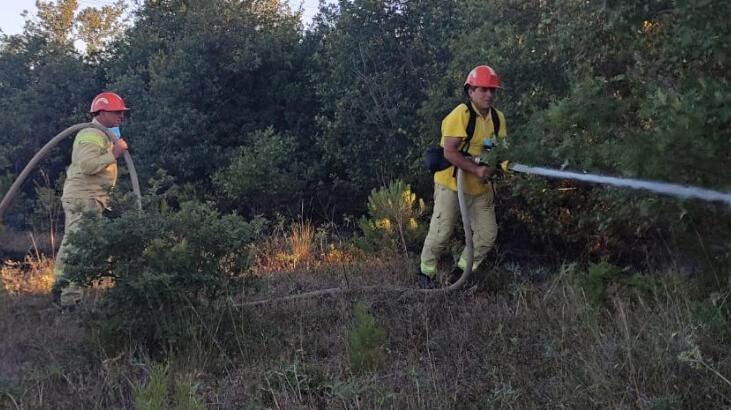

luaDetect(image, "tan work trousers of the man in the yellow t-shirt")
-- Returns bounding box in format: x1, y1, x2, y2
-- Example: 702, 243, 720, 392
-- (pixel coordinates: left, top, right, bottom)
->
421, 184, 497, 278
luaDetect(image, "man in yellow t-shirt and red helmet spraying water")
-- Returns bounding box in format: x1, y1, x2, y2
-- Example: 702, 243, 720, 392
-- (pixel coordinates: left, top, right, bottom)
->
417, 65, 507, 288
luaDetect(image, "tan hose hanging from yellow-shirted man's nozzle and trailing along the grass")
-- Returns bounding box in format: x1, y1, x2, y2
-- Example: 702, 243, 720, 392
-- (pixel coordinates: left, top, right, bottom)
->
243, 168, 474, 307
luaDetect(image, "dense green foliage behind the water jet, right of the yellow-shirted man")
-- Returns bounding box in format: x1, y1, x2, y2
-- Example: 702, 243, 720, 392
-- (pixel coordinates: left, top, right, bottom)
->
422, 1, 731, 272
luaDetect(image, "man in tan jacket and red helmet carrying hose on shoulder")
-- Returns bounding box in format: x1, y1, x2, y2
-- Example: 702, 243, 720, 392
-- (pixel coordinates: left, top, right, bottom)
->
52, 92, 128, 307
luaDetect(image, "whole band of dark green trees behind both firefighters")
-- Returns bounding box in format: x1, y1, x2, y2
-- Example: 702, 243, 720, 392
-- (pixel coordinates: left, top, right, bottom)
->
0, 0, 731, 270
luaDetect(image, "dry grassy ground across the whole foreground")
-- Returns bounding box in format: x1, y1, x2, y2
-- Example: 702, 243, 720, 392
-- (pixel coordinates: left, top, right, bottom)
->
0, 251, 731, 409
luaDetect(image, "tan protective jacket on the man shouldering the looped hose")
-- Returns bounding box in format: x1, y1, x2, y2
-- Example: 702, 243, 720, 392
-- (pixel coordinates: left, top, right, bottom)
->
61, 118, 117, 206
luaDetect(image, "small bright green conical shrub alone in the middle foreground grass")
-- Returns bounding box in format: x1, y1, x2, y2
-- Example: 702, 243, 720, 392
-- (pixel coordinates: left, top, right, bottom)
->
350, 304, 386, 372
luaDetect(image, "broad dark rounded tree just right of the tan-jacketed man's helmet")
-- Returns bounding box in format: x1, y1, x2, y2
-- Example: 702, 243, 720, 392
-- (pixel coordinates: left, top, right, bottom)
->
104, 0, 317, 192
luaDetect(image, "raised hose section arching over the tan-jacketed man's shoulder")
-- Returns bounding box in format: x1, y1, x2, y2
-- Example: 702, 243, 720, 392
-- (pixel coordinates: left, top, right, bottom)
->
0, 122, 142, 225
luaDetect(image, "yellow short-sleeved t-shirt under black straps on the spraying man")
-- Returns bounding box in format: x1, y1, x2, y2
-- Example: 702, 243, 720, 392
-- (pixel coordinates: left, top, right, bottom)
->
434, 104, 508, 195
